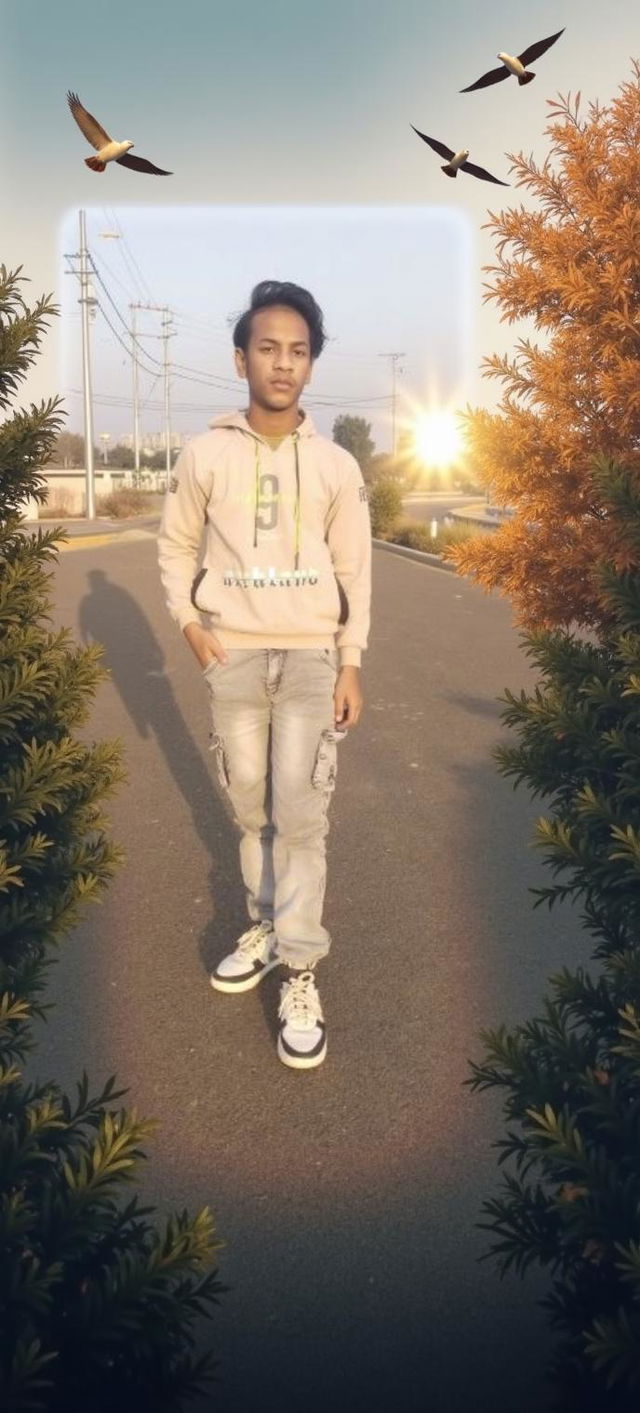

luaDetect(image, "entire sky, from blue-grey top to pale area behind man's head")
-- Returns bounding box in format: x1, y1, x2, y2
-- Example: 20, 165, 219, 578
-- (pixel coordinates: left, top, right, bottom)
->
0, 0, 640, 451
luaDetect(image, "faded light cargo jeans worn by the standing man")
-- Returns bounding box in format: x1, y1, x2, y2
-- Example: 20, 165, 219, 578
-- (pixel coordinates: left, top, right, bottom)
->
203, 647, 348, 968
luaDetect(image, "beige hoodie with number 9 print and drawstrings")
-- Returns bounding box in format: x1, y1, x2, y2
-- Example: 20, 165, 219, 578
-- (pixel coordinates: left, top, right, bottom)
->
158, 413, 372, 667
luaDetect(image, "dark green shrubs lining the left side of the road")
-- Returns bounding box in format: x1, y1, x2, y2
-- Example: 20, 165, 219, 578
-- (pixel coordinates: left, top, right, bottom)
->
0, 266, 222, 1413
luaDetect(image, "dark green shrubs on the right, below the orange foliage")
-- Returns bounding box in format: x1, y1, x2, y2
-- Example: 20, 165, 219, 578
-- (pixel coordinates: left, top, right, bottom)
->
468, 459, 640, 1413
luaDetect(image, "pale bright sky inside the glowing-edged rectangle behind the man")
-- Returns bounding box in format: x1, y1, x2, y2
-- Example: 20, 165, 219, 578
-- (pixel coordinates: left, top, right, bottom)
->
61, 206, 470, 451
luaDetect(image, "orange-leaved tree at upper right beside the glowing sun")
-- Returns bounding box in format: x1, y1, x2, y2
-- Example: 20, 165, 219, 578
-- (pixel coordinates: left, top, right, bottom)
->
445, 61, 640, 630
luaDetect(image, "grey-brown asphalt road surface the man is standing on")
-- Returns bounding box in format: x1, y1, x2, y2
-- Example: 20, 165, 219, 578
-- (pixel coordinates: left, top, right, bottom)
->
32, 536, 586, 1413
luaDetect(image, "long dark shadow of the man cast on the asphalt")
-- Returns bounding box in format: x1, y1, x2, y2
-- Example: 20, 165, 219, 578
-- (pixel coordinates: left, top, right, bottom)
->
78, 569, 247, 971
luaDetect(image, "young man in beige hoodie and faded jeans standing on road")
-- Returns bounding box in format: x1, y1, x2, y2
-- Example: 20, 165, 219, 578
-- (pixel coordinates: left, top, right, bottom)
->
158, 280, 372, 1070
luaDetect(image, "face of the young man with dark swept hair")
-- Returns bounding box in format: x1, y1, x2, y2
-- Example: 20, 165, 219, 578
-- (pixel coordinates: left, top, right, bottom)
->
236, 304, 312, 413
